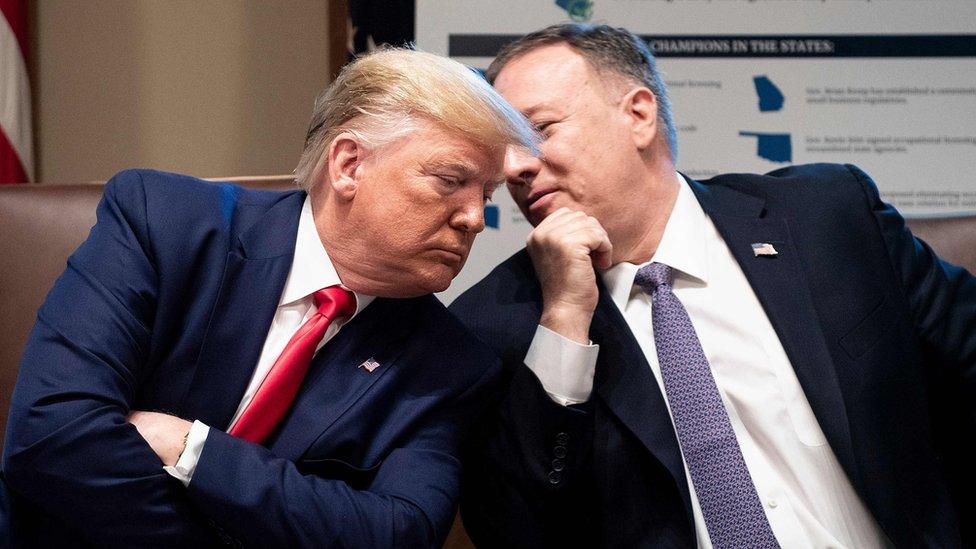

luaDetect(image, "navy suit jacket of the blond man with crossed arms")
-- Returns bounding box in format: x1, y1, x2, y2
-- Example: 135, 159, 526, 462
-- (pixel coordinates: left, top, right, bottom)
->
3, 171, 499, 547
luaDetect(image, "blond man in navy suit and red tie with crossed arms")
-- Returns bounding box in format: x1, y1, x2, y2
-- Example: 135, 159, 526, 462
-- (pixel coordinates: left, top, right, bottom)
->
3, 50, 535, 547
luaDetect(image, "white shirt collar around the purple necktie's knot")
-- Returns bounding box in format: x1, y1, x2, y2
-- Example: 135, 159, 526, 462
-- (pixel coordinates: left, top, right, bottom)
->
602, 173, 708, 311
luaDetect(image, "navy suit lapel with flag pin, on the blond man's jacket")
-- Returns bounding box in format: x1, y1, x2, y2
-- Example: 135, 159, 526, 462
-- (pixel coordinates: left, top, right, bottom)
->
268, 299, 413, 461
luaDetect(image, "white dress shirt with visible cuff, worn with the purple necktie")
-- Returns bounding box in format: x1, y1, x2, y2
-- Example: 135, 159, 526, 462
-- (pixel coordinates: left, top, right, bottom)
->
526, 175, 891, 549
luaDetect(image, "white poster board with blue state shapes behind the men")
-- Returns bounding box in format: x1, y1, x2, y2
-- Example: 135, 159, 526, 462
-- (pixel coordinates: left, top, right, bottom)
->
417, 0, 976, 301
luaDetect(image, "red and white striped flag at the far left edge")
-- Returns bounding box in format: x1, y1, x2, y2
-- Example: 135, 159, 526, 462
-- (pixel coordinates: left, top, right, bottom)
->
0, 0, 34, 183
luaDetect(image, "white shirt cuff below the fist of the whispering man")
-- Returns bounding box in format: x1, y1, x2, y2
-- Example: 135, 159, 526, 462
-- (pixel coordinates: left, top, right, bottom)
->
525, 324, 600, 406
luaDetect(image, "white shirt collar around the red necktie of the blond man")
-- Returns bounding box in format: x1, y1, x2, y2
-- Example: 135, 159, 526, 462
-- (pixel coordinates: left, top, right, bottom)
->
278, 196, 376, 316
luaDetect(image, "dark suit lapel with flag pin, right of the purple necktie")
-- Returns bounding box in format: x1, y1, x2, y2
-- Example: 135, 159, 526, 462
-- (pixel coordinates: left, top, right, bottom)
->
689, 179, 858, 485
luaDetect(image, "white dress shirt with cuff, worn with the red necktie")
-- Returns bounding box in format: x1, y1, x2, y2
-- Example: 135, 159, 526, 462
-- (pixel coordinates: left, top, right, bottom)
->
164, 197, 375, 485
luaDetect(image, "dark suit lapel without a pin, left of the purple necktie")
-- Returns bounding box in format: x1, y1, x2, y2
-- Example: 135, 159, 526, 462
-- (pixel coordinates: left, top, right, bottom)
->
590, 284, 691, 520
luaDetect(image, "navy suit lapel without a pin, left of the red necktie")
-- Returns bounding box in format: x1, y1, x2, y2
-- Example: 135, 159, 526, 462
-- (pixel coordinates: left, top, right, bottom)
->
181, 193, 305, 429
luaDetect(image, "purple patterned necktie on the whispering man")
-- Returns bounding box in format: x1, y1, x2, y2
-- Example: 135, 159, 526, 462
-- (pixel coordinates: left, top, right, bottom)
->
634, 263, 779, 549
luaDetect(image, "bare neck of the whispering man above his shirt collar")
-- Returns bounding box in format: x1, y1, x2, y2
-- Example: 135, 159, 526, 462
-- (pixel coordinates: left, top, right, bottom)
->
610, 162, 681, 265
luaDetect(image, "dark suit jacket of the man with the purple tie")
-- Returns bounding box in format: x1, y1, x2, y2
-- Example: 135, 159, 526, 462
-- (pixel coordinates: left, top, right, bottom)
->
451, 165, 976, 547
